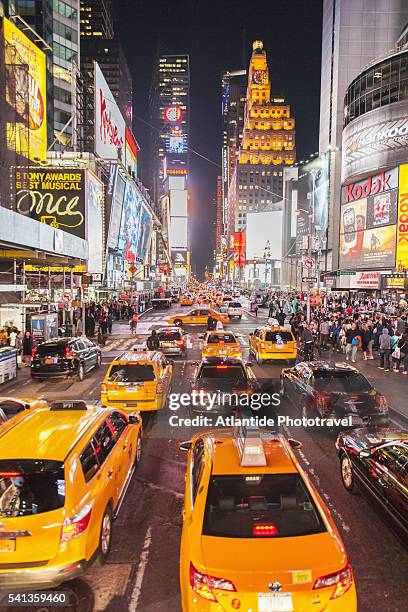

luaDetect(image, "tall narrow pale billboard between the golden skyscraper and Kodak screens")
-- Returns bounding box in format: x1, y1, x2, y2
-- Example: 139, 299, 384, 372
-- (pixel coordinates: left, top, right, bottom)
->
295, 153, 330, 253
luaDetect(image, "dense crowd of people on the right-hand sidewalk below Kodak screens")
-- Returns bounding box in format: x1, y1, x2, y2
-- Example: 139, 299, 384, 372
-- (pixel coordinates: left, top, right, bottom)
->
269, 294, 408, 374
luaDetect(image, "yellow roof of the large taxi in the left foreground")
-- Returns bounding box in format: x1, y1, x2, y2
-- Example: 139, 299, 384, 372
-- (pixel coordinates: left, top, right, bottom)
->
0, 406, 109, 461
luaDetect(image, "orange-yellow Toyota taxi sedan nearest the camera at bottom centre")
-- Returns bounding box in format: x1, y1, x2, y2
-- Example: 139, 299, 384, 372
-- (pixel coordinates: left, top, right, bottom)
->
180, 427, 357, 612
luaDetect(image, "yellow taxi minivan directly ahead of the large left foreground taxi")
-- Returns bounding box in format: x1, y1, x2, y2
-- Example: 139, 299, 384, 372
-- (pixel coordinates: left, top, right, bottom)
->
101, 349, 173, 411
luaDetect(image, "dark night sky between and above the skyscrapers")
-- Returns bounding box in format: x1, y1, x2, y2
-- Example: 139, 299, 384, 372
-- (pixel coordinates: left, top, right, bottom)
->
114, 0, 322, 273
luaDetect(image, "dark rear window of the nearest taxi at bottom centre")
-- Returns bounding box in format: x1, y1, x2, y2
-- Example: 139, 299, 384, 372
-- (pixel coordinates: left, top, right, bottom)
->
203, 474, 326, 538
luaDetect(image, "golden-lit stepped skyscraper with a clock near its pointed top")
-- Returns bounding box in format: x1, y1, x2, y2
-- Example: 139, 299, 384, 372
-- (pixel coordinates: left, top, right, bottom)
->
227, 41, 296, 235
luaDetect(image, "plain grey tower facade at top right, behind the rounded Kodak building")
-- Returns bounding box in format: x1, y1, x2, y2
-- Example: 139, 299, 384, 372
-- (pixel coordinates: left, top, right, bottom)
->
319, 0, 408, 270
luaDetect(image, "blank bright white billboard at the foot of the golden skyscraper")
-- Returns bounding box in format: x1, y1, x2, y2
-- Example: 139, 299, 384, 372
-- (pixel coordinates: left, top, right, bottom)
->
246, 210, 283, 260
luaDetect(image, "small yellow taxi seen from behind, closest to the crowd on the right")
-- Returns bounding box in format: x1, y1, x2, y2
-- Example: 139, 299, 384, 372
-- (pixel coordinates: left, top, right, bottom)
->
249, 326, 297, 365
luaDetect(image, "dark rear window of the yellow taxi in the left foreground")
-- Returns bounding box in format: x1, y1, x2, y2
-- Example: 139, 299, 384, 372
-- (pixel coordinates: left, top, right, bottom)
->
0, 459, 65, 518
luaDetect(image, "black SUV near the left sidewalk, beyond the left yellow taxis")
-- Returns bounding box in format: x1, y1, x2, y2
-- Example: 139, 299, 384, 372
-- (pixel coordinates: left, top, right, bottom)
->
31, 337, 102, 380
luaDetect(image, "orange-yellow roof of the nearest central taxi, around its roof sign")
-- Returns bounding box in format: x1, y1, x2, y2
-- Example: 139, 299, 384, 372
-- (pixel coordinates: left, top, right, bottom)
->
204, 430, 298, 475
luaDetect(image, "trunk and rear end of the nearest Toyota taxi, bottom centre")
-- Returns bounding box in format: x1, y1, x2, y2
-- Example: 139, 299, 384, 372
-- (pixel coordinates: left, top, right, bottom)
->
192, 533, 355, 612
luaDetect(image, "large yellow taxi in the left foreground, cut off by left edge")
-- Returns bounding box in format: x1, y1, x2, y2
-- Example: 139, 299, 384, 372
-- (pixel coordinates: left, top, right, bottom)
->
0, 400, 142, 590
